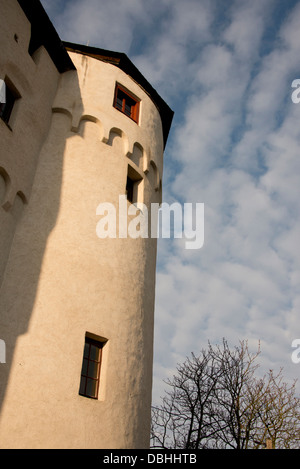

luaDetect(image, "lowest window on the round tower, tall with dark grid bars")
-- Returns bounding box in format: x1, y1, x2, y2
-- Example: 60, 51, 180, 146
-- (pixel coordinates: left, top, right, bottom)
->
79, 336, 105, 399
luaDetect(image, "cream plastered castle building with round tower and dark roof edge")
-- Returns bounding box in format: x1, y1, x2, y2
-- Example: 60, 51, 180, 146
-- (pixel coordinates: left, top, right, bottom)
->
0, 0, 173, 449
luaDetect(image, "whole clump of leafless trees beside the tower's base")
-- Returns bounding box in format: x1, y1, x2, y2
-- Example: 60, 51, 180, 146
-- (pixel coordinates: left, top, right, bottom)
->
151, 340, 300, 449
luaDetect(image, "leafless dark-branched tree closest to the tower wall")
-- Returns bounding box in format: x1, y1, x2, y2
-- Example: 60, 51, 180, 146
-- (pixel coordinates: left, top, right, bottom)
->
152, 351, 223, 449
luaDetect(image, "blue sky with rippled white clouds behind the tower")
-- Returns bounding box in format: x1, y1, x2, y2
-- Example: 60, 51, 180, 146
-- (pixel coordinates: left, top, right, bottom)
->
42, 0, 300, 403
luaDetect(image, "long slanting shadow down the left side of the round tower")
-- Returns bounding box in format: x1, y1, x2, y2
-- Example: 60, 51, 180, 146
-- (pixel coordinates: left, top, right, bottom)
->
0, 71, 82, 414
